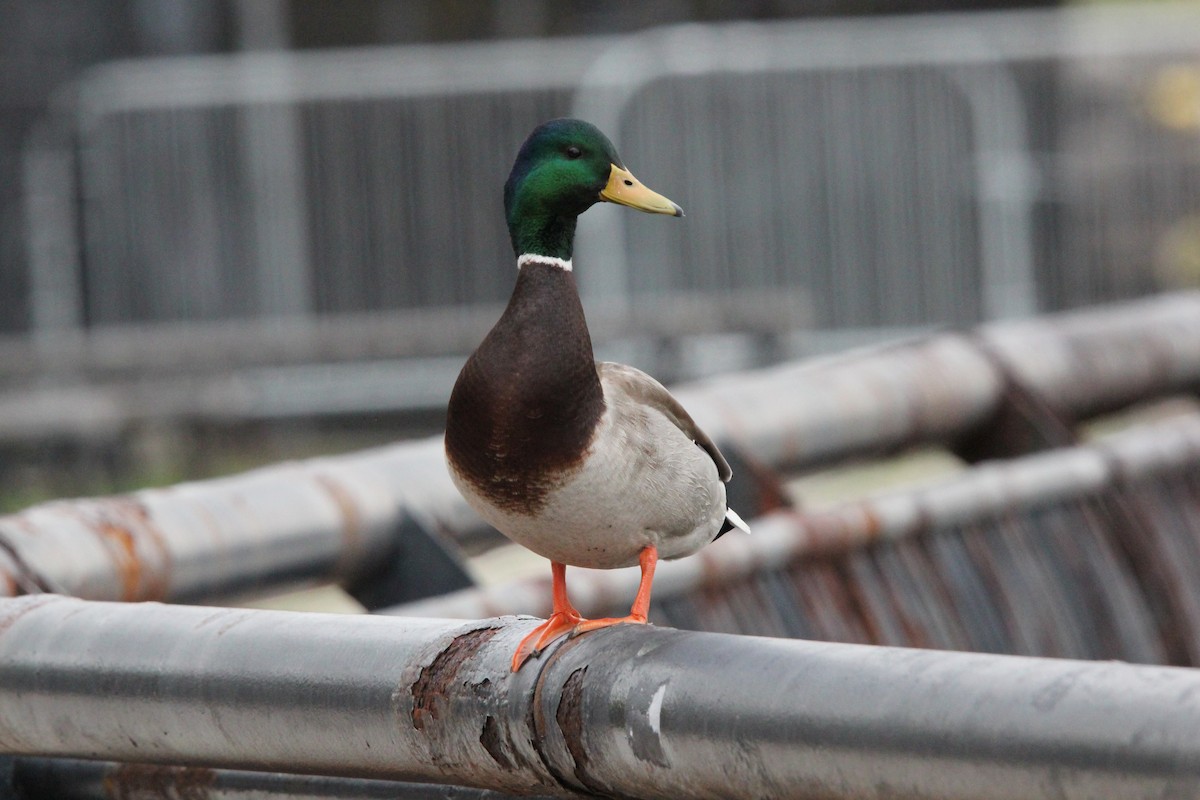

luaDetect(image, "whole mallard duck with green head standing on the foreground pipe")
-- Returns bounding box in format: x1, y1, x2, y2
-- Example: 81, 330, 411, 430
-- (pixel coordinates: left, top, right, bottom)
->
445, 119, 749, 672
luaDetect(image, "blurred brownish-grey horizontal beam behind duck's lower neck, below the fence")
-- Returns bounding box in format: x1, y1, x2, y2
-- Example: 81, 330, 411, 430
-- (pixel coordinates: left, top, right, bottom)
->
0, 290, 808, 380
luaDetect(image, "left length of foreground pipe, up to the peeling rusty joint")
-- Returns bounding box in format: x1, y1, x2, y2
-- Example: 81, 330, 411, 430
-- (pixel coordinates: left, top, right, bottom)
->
0, 595, 558, 793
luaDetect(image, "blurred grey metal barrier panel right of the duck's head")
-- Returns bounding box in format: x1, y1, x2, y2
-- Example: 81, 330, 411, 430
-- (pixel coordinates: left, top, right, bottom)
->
576, 5, 1200, 326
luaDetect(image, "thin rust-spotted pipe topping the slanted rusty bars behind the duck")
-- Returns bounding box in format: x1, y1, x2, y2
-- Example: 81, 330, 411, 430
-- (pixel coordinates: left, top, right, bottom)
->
383, 414, 1200, 619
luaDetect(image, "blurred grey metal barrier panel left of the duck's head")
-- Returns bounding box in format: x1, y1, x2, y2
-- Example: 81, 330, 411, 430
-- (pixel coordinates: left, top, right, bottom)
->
24, 40, 606, 325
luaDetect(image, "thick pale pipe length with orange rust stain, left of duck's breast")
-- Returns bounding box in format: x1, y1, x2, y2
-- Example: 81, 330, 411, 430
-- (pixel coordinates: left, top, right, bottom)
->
0, 440, 480, 601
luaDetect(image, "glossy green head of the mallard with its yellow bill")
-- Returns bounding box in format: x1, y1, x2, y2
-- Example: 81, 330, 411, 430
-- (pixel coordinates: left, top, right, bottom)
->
504, 119, 683, 260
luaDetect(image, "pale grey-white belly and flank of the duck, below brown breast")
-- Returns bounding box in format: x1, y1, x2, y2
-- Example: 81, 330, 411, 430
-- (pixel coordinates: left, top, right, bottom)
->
450, 400, 725, 569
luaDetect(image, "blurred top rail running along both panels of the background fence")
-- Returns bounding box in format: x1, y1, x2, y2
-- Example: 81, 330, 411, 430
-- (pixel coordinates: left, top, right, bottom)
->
63, 4, 1198, 119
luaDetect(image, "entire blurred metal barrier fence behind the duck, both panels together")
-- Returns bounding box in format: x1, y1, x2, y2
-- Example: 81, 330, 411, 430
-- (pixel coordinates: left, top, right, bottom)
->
26, 6, 1200, 350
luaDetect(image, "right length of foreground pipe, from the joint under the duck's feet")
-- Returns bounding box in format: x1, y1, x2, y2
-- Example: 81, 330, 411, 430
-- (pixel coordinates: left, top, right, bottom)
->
539, 628, 1200, 800
